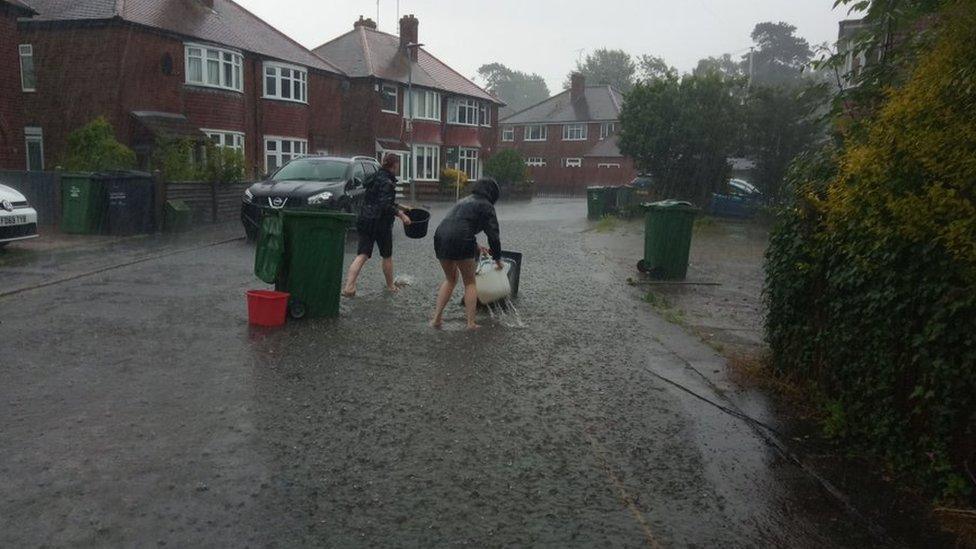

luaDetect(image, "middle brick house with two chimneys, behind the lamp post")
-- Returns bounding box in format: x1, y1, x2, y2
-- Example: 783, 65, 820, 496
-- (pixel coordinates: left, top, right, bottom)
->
313, 15, 502, 187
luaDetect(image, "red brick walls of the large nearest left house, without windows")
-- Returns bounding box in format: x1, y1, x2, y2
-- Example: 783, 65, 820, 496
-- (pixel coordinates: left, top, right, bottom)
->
17, 23, 350, 173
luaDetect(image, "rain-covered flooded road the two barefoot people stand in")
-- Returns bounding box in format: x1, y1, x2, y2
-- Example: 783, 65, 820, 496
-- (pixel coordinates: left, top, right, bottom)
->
0, 200, 880, 547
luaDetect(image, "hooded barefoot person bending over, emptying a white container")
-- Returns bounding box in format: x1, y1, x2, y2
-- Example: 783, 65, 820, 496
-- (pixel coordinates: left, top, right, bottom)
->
430, 179, 502, 330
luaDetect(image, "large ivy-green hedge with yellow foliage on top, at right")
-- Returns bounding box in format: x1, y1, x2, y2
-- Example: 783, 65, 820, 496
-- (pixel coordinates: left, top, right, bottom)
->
765, 0, 976, 499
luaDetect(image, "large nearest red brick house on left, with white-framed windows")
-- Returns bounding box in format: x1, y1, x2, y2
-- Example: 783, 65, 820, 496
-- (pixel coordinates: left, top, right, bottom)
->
12, 0, 346, 174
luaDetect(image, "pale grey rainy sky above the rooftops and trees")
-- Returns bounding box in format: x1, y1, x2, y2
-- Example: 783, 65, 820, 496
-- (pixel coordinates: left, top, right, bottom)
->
237, 0, 846, 92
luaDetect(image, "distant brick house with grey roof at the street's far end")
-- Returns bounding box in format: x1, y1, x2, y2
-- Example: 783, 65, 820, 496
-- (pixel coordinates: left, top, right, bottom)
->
498, 74, 636, 194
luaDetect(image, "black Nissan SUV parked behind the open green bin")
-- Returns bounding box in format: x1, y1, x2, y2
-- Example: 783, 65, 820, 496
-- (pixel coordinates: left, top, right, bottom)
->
241, 156, 380, 240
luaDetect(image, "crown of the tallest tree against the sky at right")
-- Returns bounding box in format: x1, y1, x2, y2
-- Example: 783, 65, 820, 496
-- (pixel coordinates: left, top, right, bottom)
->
743, 21, 813, 86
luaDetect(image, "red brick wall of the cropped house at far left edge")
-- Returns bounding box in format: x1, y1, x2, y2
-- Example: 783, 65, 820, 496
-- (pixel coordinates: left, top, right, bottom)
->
0, 4, 26, 170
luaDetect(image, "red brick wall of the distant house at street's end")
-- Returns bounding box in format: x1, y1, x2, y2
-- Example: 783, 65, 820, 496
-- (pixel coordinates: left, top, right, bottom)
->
498, 122, 637, 194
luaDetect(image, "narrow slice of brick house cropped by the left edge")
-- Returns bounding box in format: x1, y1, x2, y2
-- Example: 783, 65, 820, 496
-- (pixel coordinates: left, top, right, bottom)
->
0, 0, 40, 170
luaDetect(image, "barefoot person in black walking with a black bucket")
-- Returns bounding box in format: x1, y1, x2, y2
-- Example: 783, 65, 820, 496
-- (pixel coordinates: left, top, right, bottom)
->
342, 154, 410, 297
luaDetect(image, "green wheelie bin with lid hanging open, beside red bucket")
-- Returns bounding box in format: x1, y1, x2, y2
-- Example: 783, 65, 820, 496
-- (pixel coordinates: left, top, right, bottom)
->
275, 210, 356, 318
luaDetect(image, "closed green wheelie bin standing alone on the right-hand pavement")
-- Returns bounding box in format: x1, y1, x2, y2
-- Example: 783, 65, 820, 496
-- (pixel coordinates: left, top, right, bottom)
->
637, 200, 699, 280
